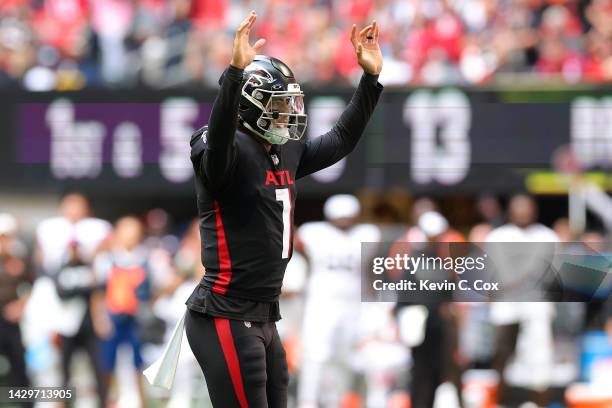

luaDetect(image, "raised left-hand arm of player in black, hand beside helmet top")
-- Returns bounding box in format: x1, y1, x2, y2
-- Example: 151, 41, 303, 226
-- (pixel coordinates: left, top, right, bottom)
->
190, 11, 265, 190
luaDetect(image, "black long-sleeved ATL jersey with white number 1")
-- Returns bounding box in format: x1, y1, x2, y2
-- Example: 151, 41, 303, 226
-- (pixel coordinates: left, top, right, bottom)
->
187, 66, 382, 322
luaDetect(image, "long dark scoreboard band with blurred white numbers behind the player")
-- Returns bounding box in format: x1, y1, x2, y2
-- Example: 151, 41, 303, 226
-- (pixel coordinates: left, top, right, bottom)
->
0, 88, 612, 195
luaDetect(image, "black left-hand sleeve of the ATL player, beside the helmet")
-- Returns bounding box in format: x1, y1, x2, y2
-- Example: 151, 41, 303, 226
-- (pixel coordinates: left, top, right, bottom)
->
190, 65, 243, 190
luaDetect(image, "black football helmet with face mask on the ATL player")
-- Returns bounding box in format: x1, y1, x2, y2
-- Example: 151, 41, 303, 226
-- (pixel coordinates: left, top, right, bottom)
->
238, 55, 307, 144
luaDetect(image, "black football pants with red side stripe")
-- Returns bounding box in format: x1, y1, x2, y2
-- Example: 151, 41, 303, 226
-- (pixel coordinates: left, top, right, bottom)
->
185, 310, 289, 408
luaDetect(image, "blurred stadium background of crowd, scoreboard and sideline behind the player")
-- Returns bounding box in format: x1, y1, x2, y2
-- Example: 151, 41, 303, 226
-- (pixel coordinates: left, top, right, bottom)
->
0, 0, 612, 408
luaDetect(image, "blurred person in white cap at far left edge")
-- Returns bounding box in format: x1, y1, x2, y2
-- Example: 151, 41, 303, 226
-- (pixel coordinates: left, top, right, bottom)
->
0, 213, 34, 387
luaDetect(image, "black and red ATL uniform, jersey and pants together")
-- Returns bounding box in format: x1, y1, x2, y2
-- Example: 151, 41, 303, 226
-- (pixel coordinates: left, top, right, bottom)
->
186, 66, 382, 408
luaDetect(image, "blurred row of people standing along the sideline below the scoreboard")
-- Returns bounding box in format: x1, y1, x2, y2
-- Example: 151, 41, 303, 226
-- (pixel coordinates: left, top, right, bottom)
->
0, 193, 612, 408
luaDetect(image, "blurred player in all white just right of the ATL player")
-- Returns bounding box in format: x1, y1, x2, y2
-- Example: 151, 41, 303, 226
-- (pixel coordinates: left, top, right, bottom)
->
296, 195, 380, 408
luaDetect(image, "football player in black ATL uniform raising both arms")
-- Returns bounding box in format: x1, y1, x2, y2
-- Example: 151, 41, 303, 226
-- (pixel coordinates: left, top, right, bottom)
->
185, 12, 382, 408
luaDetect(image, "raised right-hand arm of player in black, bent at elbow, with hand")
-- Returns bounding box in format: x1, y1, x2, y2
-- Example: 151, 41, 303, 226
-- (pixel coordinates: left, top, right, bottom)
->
296, 21, 383, 178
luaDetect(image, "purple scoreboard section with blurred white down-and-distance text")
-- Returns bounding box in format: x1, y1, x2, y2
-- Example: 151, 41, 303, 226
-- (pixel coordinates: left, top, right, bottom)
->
19, 98, 211, 183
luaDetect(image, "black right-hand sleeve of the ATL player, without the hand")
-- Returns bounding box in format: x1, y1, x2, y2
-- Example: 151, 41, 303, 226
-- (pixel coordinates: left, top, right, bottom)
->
296, 73, 383, 178
